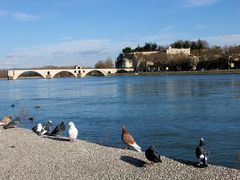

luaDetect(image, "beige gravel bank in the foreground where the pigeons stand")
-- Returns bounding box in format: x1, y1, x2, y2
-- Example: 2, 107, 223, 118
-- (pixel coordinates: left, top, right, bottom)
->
0, 128, 240, 180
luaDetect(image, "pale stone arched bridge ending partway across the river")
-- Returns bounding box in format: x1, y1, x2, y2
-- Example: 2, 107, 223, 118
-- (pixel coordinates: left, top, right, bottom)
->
8, 66, 134, 80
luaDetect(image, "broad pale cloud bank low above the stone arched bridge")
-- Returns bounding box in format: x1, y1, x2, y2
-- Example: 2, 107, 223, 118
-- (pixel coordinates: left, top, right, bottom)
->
0, 39, 126, 68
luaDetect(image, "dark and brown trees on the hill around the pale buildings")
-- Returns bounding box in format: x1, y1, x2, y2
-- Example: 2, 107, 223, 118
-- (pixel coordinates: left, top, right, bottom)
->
116, 39, 240, 71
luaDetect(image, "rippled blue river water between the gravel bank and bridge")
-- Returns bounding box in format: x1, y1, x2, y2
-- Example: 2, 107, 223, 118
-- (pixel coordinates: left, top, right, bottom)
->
0, 75, 240, 168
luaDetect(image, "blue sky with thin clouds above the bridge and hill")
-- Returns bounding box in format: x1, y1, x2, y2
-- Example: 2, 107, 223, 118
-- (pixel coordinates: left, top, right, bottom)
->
0, 0, 240, 68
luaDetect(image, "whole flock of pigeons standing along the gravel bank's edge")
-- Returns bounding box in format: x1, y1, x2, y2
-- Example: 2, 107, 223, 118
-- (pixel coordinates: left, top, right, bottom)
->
0, 112, 210, 167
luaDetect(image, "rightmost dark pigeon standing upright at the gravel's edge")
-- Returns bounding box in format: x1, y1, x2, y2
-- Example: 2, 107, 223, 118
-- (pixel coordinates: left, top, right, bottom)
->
196, 138, 210, 167
